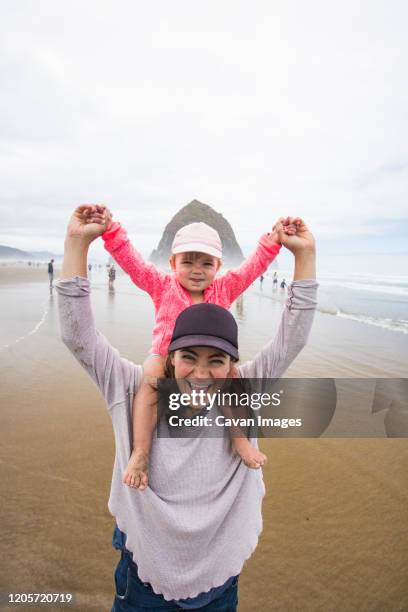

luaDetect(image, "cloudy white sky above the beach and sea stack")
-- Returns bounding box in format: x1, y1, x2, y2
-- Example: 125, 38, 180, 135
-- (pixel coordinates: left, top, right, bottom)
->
0, 0, 408, 255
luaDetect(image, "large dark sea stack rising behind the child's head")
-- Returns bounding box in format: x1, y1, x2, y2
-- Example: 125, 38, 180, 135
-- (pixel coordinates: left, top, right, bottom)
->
149, 200, 244, 266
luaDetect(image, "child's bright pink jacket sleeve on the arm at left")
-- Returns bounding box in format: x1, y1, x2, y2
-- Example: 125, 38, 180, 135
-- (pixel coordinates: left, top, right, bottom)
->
102, 223, 167, 300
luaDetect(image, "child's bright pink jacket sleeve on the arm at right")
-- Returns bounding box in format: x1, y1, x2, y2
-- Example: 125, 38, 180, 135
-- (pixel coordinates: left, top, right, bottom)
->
214, 234, 282, 304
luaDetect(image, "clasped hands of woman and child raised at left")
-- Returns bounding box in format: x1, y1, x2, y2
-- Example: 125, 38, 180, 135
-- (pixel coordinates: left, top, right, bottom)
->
67, 204, 112, 244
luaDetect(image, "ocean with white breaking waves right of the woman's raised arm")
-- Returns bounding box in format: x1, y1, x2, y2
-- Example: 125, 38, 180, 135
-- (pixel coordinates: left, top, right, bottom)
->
264, 254, 408, 334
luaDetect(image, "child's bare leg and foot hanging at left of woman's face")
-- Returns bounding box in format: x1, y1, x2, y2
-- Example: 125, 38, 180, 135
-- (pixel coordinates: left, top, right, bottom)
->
123, 355, 165, 491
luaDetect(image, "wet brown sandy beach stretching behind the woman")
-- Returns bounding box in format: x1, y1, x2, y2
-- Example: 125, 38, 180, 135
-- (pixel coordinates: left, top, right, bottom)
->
0, 267, 408, 612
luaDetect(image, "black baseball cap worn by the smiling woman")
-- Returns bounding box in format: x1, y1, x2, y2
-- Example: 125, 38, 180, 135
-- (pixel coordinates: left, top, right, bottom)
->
169, 304, 239, 359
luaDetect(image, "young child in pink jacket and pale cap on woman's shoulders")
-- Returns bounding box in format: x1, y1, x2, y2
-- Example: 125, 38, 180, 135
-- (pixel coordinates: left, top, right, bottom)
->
88, 206, 296, 490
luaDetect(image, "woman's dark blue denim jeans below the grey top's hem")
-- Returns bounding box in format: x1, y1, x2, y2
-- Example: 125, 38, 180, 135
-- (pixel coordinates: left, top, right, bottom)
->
111, 550, 238, 612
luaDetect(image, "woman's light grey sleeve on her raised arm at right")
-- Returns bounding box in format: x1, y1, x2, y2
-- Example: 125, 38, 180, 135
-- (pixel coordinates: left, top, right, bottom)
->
239, 280, 318, 379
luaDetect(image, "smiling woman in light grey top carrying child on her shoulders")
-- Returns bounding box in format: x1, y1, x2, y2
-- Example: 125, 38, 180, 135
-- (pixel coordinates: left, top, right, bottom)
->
57, 207, 317, 612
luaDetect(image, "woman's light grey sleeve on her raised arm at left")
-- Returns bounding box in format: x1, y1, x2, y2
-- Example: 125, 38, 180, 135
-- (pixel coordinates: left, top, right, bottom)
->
55, 276, 141, 408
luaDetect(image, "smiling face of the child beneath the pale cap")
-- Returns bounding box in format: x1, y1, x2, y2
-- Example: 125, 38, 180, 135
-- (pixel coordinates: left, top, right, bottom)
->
170, 253, 221, 293
